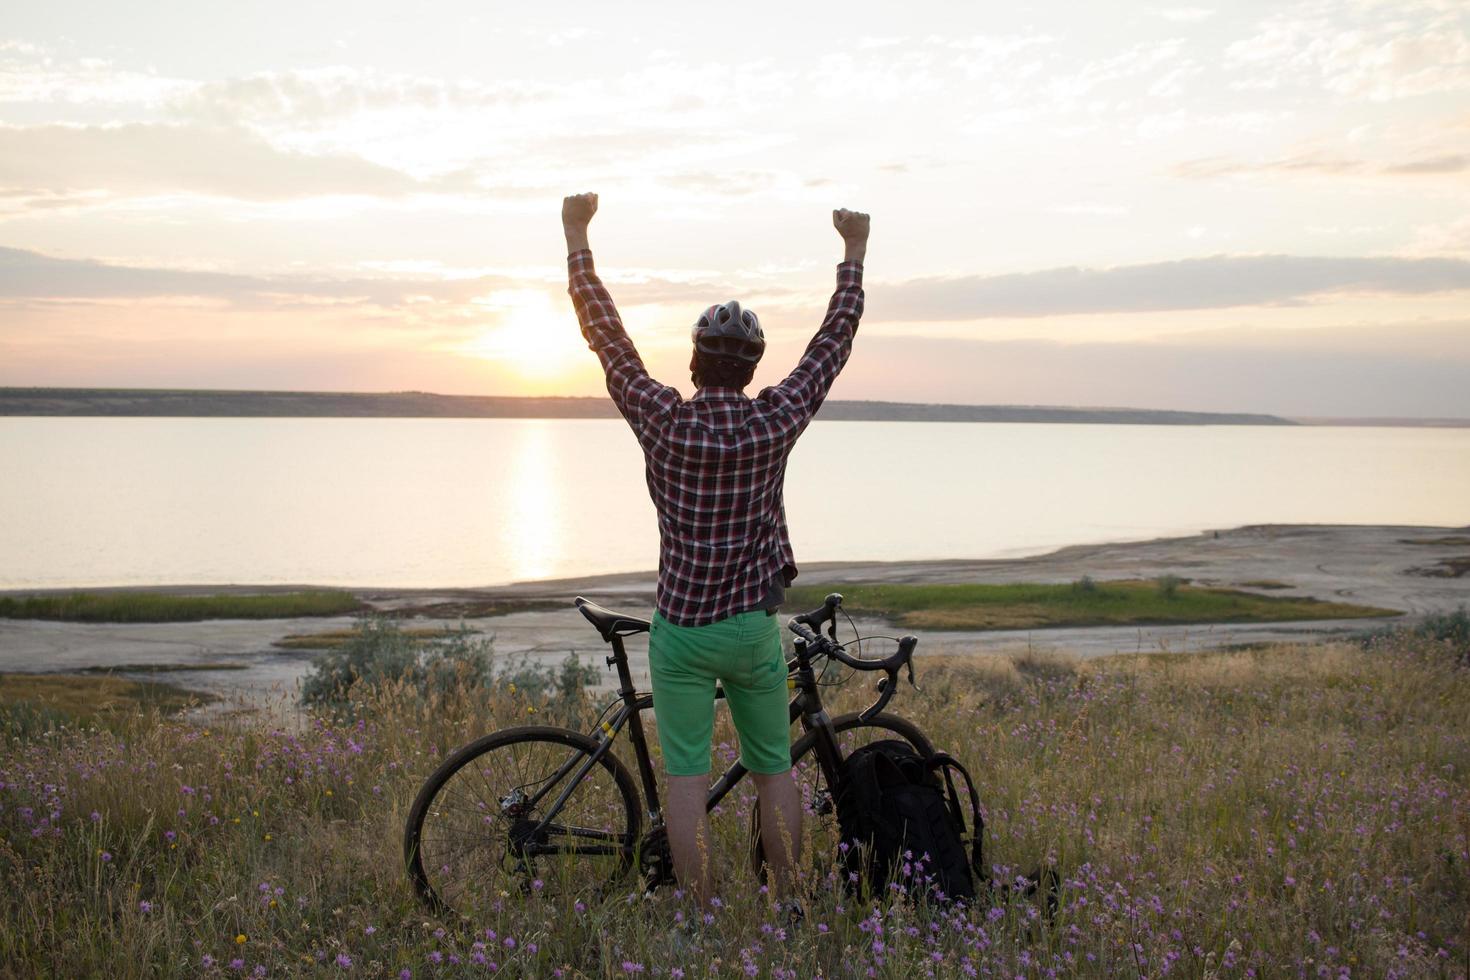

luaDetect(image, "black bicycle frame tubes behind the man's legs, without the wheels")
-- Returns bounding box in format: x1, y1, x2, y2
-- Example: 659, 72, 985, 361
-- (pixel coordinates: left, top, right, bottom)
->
528, 635, 842, 854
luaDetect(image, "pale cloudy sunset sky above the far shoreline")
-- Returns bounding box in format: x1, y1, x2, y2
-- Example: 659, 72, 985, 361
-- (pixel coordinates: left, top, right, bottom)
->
0, 0, 1470, 416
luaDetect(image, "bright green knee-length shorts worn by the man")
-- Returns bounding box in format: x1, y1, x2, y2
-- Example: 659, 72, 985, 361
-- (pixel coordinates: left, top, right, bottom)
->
648, 610, 791, 776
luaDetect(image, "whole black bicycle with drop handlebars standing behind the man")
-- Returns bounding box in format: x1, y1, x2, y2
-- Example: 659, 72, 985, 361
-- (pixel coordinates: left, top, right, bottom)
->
403, 592, 933, 915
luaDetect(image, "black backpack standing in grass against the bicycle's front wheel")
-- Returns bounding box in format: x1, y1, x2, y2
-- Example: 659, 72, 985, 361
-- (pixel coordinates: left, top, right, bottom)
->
836, 739, 986, 904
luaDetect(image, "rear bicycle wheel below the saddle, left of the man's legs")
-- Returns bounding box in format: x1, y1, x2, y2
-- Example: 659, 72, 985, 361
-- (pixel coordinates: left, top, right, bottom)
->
403, 727, 639, 915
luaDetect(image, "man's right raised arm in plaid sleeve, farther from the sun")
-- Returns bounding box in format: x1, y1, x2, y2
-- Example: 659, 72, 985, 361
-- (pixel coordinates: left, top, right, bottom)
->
763, 209, 869, 426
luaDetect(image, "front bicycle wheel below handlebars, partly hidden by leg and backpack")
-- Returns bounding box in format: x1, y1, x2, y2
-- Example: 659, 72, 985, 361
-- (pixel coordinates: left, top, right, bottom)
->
751, 711, 933, 887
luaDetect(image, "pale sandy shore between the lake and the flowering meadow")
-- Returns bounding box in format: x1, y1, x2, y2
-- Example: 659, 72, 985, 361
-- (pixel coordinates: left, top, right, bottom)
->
0, 525, 1470, 719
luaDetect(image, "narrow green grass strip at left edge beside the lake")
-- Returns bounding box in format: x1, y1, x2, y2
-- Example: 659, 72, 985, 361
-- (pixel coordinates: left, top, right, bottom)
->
0, 589, 362, 623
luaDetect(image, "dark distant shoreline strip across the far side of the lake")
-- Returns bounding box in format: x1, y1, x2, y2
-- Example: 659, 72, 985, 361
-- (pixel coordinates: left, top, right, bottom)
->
0, 388, 1299, 426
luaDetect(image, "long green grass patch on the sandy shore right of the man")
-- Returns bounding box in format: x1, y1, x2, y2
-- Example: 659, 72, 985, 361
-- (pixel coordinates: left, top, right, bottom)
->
786, 579, 1399, 629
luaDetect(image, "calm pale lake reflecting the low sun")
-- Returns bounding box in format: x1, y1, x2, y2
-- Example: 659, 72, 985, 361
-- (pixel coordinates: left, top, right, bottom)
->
0, 417, 1470, 589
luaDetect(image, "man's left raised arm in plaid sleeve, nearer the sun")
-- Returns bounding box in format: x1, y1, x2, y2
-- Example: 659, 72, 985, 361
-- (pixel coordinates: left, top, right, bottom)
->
562, 194, 679, 428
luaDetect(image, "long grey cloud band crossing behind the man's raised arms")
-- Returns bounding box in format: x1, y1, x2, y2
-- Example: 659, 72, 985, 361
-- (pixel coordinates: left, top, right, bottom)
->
14, 248, 1470, 320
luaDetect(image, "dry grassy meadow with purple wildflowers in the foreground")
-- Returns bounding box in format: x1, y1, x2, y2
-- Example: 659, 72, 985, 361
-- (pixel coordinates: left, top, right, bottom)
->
0, 620, 1470, 980
